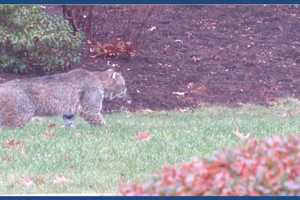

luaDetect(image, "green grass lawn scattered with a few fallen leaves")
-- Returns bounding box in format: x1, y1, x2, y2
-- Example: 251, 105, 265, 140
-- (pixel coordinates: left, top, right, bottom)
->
0, 99, 300, 194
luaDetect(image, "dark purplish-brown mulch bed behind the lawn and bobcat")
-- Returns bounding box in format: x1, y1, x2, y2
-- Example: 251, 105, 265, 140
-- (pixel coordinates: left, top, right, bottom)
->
0, 5, 300, 111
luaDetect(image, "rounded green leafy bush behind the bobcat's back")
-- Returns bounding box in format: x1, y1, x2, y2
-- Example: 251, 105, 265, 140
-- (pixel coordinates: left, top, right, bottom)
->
0, 5, 83, 72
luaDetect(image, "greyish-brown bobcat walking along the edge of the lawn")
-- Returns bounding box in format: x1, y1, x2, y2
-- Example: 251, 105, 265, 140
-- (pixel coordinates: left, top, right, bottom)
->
0, 69, 128, 128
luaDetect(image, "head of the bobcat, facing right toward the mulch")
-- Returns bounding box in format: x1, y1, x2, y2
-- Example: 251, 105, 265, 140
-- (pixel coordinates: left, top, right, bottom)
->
97, 69, 131, 103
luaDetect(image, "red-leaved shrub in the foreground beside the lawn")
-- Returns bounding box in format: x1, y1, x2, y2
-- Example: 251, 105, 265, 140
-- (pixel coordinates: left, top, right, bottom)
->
120, 136, 300, 196
